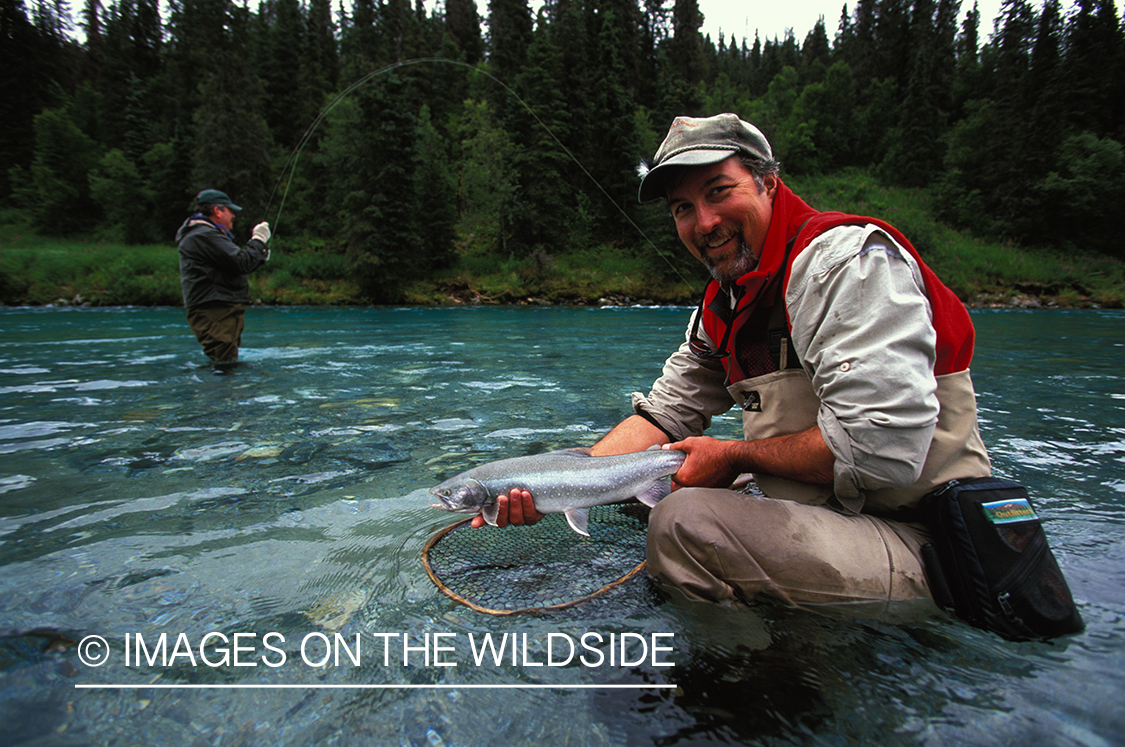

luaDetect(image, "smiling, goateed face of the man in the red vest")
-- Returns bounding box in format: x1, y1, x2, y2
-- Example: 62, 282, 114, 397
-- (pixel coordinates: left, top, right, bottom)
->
668, 155, 777, 284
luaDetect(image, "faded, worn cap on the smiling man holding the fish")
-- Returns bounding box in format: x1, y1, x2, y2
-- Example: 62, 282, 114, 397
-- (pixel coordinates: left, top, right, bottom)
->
637, 114, 773, 203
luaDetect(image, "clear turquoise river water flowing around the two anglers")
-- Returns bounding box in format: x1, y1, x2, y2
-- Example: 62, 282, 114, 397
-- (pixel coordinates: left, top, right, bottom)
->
0, 308, 1125, 746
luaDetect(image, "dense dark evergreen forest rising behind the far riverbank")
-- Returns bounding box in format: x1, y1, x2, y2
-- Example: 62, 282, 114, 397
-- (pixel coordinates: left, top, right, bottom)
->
0, 0, 1125, 300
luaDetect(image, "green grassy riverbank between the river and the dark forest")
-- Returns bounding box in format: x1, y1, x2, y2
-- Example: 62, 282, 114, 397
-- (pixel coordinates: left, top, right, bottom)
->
0, 172, 1125, 308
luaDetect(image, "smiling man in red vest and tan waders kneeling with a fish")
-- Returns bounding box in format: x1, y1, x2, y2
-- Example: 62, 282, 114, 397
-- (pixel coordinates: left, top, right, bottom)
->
474, 114, 990, 604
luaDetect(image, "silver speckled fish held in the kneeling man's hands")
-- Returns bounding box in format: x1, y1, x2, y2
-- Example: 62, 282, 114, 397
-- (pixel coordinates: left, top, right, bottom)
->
430, 447, 686, 537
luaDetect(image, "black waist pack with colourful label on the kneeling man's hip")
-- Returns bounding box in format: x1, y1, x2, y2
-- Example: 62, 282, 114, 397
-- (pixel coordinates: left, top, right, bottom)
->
920, 477, 1085, 640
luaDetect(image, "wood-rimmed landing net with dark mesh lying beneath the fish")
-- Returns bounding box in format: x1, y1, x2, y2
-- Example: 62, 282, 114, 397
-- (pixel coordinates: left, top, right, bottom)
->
422, 502, 648, 614
